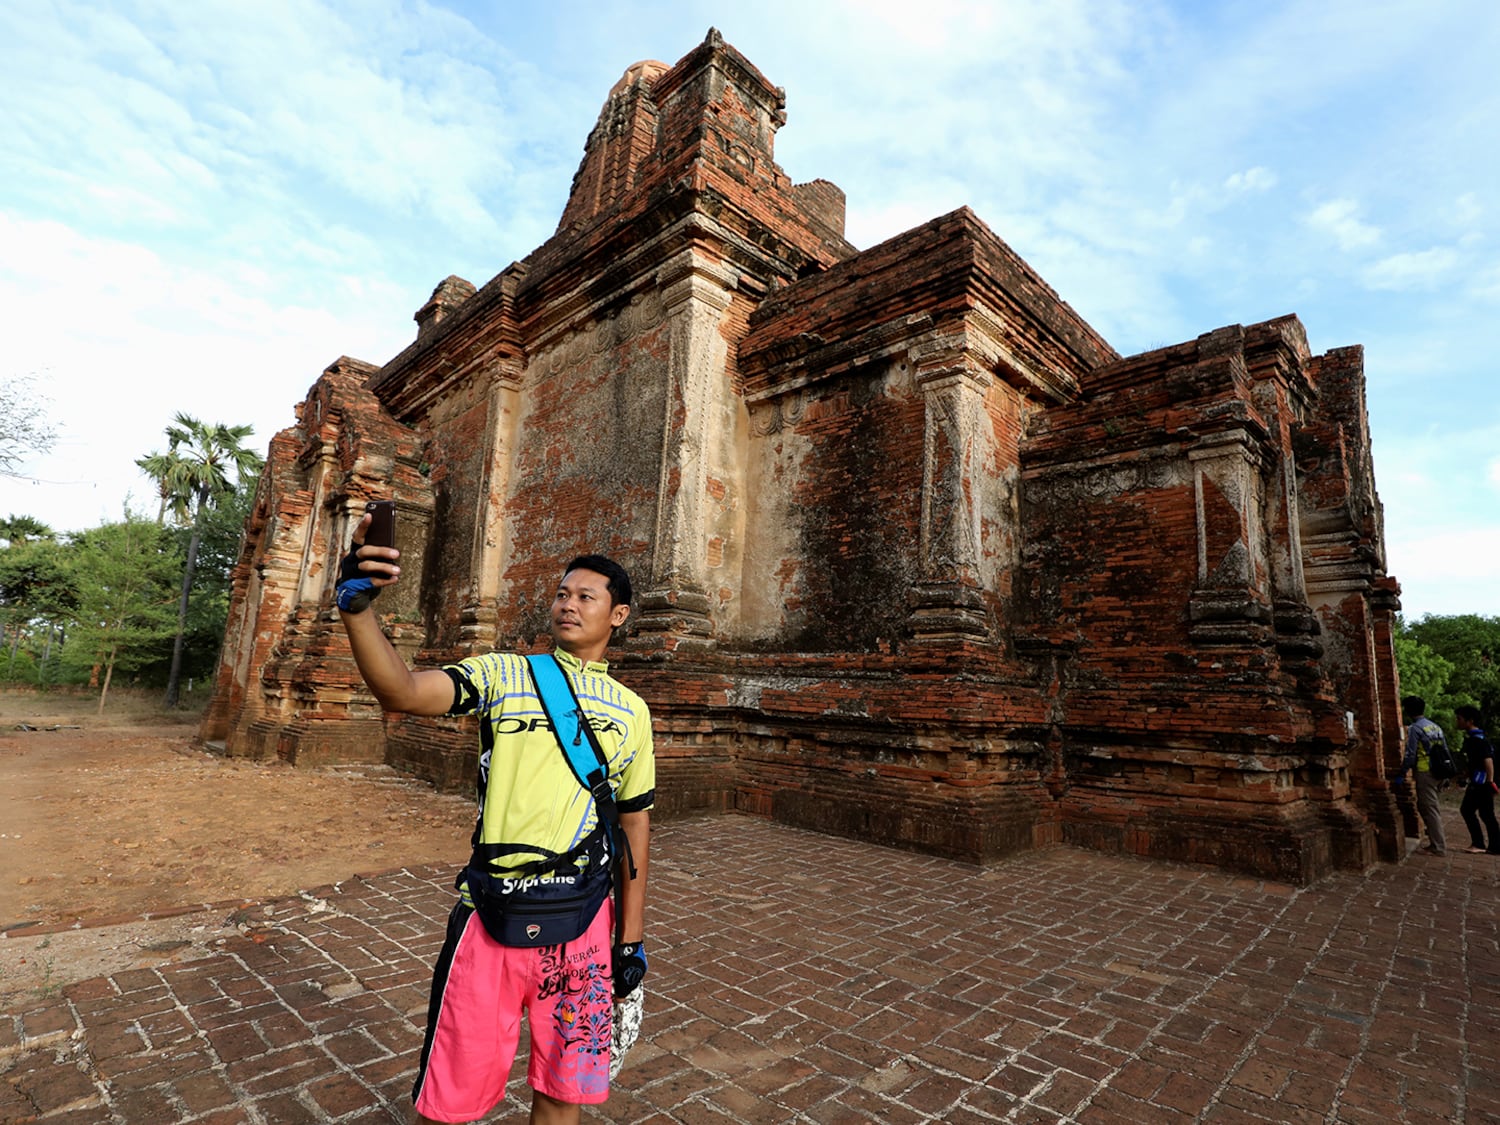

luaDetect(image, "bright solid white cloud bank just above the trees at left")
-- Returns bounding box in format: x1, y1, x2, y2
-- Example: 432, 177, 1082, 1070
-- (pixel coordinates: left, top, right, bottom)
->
0, 215, 414, 540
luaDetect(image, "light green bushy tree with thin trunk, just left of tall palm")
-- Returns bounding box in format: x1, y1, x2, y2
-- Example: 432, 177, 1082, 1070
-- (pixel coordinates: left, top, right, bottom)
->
63, 513, 182, 713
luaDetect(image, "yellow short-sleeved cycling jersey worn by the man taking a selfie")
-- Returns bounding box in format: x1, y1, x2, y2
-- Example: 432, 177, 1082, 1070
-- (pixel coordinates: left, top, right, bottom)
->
444, 650, 656, 869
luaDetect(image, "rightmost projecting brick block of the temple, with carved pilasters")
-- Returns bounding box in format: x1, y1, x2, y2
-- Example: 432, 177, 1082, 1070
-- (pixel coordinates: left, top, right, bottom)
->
1023, 321, 1397, 881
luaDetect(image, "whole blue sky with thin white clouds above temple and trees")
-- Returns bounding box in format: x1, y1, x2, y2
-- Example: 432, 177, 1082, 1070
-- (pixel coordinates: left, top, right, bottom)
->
0, 0, 1500, 618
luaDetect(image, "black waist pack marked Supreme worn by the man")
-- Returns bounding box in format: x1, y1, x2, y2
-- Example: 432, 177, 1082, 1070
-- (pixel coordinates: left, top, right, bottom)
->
459, 840, 611, 948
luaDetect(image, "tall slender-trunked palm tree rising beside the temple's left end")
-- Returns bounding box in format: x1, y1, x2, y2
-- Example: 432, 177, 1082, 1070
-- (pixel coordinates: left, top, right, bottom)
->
135, 414, 261, 708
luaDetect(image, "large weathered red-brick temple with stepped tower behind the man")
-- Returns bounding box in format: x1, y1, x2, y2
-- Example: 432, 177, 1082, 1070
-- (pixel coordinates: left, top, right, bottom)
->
203, 32, 1406, 884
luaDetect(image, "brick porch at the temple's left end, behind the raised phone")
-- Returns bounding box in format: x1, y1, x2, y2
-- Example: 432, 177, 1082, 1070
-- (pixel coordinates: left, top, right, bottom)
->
201, 359, 431, 764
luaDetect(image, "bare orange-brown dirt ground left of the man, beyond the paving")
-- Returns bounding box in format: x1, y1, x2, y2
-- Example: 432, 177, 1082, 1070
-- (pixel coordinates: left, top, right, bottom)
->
0, 692, 474, 1010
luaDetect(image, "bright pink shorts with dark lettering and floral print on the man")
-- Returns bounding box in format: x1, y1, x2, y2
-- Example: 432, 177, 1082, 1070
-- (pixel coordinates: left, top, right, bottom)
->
413, 899, 615, 1121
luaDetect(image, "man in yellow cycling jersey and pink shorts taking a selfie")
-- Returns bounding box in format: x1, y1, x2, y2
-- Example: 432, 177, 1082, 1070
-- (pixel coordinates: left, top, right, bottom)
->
336, 516, 656, 1125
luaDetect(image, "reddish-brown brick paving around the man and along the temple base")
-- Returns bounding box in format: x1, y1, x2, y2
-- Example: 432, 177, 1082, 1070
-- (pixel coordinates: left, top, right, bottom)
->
0, 816, 1500, 1125
